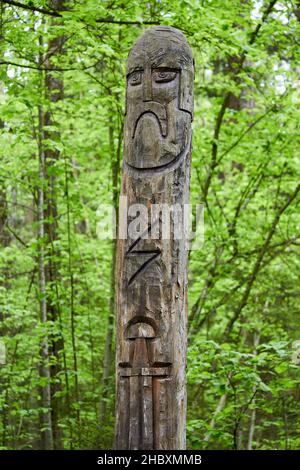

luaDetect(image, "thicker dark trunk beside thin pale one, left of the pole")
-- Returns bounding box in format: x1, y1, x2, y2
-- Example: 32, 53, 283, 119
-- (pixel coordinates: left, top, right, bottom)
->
44, 0, 64, 449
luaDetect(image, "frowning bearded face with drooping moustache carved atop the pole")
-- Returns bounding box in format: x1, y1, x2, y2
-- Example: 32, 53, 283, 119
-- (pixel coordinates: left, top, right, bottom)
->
125, 27, 193, 169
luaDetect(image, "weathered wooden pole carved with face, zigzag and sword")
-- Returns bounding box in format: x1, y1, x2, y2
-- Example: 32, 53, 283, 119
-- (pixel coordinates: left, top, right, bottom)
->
116, 26, 194, 450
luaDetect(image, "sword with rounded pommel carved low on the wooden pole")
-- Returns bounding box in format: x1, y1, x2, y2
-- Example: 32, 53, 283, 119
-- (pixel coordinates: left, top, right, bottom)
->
119, 315, 172, 449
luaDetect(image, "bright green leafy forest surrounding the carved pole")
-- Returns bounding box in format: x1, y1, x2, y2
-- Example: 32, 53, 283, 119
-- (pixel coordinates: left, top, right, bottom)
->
0, 0, 300, 449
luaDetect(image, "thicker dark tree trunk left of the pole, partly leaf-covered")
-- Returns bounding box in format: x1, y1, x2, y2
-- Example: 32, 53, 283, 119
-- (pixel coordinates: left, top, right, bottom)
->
40, 0, 67, 449
